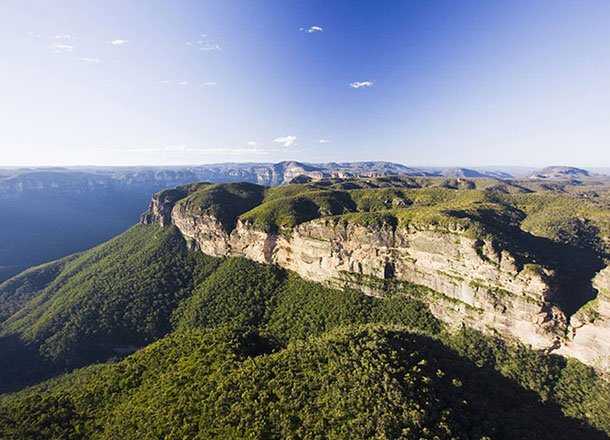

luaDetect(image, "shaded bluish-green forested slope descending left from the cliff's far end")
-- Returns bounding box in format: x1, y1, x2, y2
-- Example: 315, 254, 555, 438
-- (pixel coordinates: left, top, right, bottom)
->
0, 226, 217, 389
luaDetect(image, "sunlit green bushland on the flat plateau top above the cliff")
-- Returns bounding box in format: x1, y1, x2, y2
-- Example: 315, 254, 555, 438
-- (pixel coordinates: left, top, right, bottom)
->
156, 177, 610, 258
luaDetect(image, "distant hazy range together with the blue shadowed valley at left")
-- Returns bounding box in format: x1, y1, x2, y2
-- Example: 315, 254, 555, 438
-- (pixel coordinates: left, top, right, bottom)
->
0, 161, 604, 281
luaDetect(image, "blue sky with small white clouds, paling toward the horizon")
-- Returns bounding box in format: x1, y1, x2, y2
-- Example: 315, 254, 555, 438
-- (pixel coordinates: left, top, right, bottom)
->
0, 0, 610, 167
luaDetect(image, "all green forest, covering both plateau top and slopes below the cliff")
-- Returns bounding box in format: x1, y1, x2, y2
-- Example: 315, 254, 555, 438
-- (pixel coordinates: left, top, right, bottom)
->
0, 178, 610, 440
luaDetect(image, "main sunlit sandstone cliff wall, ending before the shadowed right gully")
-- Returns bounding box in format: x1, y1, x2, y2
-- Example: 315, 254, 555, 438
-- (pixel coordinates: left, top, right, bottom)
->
172, 207, 565, 348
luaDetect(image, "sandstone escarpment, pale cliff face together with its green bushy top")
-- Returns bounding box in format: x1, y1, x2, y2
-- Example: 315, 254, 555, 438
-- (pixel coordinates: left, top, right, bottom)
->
142, 179, 610, 371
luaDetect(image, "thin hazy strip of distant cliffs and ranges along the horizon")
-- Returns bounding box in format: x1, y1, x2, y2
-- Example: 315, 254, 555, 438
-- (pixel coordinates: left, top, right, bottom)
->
0, 161, 610, 196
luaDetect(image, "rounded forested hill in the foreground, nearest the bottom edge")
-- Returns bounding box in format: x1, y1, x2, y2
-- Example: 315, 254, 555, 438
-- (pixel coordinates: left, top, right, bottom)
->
0, 325, 605, 440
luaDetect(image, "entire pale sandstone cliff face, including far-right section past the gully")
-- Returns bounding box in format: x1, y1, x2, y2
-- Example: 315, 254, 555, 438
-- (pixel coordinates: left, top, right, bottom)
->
143, 184, 610, 371
